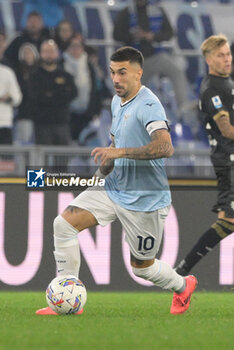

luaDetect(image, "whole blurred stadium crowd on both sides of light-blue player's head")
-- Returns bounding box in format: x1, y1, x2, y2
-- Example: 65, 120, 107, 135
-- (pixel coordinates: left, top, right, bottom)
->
0, 0, 234, 146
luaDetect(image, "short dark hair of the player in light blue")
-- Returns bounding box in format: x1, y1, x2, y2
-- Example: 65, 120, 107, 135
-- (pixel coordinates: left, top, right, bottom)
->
110, 46, 144, 68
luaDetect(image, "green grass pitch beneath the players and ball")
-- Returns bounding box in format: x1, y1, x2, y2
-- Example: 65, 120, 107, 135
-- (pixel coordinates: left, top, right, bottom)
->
0, 292, 234, 350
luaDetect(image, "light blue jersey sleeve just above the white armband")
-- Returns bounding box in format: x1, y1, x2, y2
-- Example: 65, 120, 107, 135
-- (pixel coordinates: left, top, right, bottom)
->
138, 99, 168, 129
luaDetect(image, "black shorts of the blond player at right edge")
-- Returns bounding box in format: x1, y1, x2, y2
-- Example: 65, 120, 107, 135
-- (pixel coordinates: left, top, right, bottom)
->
212, 162, 234, 218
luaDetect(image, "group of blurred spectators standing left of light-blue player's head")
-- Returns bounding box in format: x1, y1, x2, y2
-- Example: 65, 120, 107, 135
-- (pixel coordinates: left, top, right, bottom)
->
0, 11, 111, 145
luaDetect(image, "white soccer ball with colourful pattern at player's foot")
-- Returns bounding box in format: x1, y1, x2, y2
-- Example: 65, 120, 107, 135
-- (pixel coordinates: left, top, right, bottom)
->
46, 275, 87, 315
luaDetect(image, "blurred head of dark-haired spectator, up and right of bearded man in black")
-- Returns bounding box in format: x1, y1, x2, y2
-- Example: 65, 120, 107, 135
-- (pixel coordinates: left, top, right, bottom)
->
54, 20, 74, 53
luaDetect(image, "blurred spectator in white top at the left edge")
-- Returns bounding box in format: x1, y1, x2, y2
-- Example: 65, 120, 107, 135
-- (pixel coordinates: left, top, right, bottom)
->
0, 63, 22, 144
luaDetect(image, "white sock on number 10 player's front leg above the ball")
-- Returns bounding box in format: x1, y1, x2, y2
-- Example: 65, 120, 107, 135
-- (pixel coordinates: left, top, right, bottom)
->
54, 215, 80, 278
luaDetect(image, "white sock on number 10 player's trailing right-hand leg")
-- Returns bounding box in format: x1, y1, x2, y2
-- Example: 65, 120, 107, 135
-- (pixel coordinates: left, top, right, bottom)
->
132, 259, 185, 293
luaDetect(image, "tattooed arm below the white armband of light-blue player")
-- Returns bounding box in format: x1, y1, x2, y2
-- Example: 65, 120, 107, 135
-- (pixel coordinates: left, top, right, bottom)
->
91, 129, 174, 166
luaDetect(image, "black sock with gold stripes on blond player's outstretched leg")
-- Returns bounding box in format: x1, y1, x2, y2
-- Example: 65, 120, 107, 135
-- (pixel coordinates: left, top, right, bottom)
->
178, 219, 234, 274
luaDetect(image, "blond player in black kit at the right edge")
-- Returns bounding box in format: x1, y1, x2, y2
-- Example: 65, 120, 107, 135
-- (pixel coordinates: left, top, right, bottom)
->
176, 35, 234, 276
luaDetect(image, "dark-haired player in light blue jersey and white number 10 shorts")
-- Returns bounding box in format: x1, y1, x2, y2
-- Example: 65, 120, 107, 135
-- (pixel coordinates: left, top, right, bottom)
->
37, 47, 197, 314
